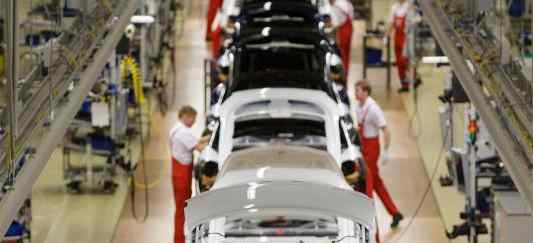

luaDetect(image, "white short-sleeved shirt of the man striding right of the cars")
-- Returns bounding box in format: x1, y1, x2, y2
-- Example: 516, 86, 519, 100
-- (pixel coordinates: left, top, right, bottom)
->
355, 97, 387, 138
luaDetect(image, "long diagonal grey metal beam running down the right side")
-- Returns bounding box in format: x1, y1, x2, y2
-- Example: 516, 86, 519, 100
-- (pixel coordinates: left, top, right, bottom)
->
420, 0, 533, 211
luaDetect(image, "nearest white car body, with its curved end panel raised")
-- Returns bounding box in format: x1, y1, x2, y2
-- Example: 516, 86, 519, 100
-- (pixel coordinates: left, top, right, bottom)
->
185, 146, 376, 243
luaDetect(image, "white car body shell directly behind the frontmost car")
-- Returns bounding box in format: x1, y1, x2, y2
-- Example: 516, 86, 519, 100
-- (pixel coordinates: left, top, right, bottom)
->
199, 88, 361, 167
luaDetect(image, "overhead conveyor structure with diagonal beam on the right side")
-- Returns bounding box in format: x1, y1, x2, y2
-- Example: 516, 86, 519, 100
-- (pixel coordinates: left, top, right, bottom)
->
419, 0, 533, 214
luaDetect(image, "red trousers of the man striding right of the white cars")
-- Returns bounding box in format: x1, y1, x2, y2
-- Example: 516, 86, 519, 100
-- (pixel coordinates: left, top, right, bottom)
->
361, 136, 398, 215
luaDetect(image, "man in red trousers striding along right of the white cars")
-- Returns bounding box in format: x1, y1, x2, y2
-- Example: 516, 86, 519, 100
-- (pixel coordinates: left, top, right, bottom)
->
355, 81, 403, 228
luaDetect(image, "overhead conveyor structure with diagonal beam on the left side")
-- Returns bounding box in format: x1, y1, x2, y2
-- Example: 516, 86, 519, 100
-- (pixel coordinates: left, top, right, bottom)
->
0, 0, 138, 237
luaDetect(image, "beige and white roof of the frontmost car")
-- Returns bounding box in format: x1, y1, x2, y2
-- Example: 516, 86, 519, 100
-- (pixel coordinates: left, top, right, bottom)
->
213, 145, 351, 190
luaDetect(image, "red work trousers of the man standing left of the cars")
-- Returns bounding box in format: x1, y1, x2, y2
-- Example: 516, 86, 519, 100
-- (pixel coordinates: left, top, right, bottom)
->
172, 158, 192, 243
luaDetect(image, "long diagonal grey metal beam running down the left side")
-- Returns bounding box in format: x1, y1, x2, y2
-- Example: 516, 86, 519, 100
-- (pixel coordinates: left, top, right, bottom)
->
0, 0, 138, 233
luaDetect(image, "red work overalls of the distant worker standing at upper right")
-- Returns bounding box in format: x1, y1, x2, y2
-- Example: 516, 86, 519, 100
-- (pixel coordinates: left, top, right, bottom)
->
394, 16, 409, 88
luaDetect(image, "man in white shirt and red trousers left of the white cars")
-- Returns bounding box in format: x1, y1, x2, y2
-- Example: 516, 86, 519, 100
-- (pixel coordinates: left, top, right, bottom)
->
169, 105, 209, 243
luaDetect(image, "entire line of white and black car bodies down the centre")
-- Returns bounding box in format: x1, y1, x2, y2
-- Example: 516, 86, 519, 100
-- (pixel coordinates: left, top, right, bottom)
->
186, 0, 376, 243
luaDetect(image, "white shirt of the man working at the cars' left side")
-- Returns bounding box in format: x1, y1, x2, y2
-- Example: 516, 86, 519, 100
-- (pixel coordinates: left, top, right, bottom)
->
169, 122, 198, 165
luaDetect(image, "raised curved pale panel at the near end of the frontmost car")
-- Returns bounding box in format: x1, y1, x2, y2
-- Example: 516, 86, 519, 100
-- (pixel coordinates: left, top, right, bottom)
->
185, 181, 376, 232
